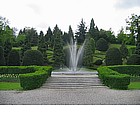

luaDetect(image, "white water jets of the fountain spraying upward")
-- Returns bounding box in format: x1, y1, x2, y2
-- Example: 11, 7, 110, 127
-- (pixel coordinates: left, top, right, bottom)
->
68, 39, 86, 72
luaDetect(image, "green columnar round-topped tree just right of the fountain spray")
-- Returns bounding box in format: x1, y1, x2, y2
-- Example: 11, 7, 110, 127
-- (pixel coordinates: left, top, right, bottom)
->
83, 38, 95, 67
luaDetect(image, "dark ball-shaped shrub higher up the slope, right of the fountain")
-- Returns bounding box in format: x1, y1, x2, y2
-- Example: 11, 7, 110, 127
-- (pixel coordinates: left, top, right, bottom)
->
96, 38, 109, 51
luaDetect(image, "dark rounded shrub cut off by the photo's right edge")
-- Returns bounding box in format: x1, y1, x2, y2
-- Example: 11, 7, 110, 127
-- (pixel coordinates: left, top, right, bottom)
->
127, 54, 140, 65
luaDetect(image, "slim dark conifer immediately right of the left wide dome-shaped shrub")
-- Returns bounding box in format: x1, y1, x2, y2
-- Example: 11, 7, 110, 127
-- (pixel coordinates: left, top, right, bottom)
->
38, 31, 48, 64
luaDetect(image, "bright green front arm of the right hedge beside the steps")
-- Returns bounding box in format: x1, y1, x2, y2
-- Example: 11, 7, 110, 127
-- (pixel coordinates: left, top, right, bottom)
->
97, 66, 130, 89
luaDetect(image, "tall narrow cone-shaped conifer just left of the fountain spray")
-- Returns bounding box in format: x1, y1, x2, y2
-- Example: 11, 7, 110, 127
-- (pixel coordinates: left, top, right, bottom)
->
53, 26, 64, 68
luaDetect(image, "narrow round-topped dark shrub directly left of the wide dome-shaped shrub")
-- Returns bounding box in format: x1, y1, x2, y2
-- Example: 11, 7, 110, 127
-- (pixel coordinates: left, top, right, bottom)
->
8, 50, 20, 66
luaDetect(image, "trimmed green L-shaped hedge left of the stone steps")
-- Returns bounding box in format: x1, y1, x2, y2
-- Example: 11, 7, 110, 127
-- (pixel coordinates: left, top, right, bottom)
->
0, 66, 52, 90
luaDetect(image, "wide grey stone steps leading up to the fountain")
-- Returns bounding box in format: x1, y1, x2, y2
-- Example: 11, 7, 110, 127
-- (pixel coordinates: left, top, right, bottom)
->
42, 72, 104, 89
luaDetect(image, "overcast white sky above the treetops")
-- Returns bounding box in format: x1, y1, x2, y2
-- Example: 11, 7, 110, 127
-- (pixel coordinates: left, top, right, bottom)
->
0, 0, 140, 33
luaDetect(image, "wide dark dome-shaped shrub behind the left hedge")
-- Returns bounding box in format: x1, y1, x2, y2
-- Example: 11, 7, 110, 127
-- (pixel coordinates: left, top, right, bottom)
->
22, 50, 44, 66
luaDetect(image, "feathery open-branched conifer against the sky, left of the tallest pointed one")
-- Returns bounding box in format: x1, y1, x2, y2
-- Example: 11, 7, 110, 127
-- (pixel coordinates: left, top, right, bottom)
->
75, 19, 87, 44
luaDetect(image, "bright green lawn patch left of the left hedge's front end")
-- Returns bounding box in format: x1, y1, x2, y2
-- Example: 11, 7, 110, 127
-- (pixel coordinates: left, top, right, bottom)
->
0, 82, 22, 90
